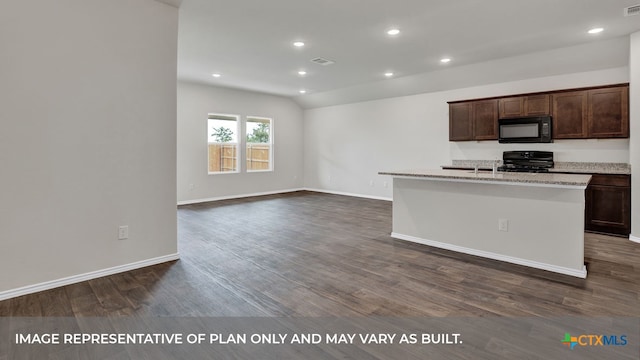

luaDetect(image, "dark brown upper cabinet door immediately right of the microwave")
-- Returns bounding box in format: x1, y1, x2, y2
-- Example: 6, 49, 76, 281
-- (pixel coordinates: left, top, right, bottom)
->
551, 91, 588, 139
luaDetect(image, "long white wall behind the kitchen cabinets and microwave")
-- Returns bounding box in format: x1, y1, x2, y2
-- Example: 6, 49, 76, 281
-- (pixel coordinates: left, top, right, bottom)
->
304, 67, 629, 198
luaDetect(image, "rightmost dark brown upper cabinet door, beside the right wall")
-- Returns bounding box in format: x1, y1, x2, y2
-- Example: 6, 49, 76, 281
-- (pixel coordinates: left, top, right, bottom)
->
589, 86, 629, 138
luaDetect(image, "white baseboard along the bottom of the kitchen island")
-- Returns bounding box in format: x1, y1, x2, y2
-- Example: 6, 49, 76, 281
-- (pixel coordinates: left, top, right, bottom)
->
391, 233, 587, 279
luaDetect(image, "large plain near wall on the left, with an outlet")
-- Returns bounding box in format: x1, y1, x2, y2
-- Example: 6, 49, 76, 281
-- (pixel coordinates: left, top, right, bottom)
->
0, 0, 178, 298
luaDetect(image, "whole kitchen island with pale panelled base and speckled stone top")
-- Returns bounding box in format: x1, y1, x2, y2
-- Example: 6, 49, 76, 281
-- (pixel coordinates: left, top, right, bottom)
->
379, 170, 591, 278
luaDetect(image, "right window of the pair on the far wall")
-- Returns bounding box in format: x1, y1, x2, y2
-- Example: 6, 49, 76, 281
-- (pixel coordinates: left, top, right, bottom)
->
246, 116, 273, 172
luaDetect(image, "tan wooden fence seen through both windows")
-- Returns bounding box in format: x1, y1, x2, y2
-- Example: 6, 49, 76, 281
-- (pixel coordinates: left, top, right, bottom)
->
209, 144, 271, 172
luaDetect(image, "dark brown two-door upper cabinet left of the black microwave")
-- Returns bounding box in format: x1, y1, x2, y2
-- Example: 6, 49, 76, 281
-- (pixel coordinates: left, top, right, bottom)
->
449, 99, 498, 141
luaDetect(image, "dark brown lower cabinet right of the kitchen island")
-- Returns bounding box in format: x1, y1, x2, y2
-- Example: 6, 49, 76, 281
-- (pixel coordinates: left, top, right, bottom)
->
585, 174, 631, 236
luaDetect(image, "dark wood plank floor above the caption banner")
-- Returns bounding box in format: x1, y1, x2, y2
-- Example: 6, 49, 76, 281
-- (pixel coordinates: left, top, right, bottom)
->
0, 192, 640, 317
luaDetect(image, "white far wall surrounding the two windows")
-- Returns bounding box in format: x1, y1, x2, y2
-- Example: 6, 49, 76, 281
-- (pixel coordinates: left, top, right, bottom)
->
177, 82, 303, 203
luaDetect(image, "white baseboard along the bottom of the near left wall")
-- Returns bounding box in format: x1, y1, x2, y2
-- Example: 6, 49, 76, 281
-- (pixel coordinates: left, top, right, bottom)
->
0, 253, 180, 301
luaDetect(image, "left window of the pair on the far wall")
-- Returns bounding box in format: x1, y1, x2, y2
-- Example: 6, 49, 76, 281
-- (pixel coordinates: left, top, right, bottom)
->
207, 114, 240, 174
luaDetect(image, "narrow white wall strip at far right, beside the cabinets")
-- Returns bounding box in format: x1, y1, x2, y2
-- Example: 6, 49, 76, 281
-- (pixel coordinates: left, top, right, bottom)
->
629, 32, 640, 242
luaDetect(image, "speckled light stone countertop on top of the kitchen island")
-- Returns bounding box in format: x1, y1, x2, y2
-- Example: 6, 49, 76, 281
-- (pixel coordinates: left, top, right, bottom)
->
378, 169, 591, 188
